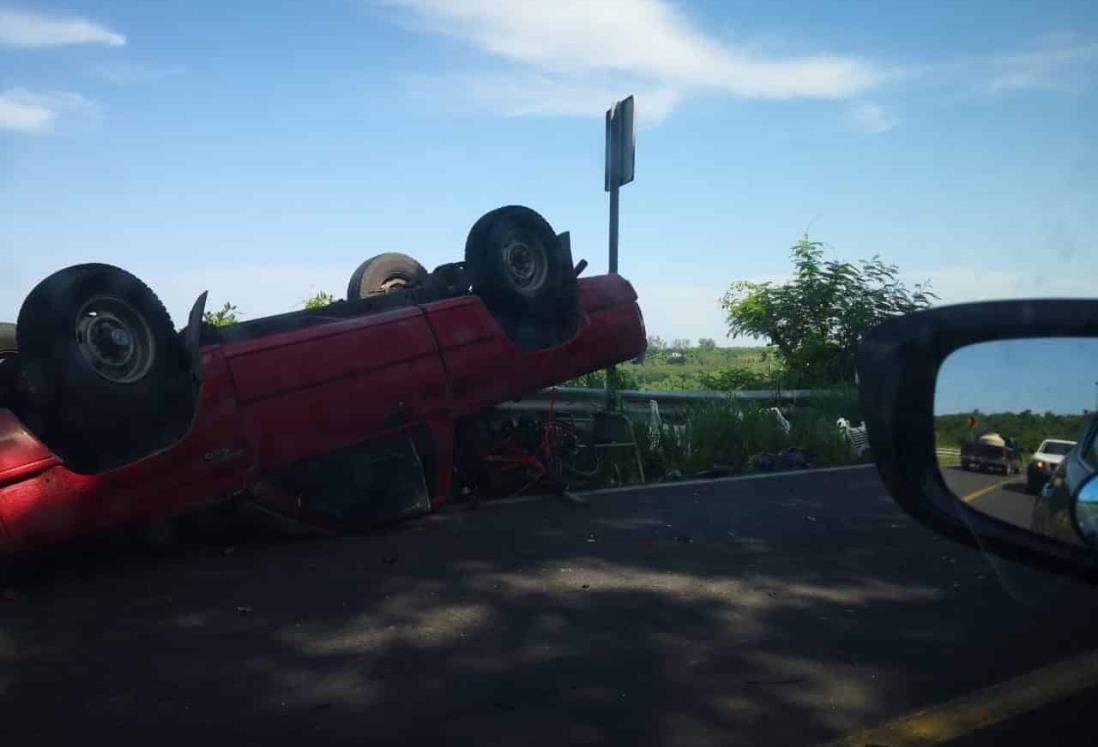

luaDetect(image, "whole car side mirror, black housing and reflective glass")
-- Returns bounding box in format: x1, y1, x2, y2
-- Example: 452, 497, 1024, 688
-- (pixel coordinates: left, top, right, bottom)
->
858, 300, 1098, 580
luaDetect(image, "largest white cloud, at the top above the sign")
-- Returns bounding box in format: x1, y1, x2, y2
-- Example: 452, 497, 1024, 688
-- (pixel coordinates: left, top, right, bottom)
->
383, 0, 884, 119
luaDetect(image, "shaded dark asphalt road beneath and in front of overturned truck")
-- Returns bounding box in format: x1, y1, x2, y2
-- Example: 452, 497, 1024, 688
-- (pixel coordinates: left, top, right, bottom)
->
0, 468, 1098, 747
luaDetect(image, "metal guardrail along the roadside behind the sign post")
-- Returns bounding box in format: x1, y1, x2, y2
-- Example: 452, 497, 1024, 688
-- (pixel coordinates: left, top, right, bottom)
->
497, 387, 822, 414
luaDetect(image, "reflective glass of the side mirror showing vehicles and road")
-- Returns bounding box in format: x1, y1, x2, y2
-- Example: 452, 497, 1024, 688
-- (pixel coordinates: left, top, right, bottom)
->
934, 337, 1098, 544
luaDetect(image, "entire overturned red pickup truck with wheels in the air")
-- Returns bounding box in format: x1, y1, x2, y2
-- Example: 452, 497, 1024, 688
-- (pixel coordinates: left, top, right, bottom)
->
0, 207, 646, 550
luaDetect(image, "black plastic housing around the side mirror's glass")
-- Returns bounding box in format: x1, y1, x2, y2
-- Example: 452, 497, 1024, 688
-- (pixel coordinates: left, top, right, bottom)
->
856, 300, 1098, 580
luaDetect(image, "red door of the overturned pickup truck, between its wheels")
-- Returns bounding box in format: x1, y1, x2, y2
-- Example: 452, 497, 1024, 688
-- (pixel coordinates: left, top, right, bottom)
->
226, 306, 452, 518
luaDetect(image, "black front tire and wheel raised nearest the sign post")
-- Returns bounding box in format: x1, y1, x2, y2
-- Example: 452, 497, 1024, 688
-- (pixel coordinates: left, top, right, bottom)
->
466, 205, 574, 314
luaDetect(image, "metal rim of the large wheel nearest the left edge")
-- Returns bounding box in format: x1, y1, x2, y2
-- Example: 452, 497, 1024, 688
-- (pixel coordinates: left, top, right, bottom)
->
76, 296, 156, 383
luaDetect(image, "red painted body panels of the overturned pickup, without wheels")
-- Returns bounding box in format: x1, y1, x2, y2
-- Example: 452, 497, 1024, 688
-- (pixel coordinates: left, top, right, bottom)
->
0, 275, 646, 550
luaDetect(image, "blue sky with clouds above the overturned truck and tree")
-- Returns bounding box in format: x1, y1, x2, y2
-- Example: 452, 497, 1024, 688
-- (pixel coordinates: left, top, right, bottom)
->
0, 0, 1098, 338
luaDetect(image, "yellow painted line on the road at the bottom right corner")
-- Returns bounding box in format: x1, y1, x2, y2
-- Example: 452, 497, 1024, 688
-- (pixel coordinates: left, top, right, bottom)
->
829, 651, 1098, 747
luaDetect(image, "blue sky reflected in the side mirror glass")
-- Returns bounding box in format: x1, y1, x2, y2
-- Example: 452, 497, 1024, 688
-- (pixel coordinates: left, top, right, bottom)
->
934, 337, 1098, 415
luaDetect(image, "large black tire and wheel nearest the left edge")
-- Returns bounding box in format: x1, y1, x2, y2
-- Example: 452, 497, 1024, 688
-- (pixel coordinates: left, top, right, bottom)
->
16, 265, 197, 472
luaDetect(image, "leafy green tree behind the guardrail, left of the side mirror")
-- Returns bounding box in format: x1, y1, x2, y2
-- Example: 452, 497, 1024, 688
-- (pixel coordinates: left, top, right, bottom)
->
720, 236, 938, 386
